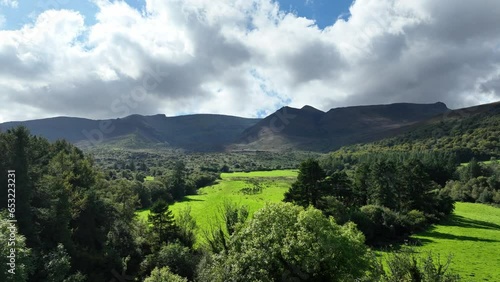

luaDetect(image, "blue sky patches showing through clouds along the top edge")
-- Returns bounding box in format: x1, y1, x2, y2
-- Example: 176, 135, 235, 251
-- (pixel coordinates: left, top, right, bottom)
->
0, 0, 353, 30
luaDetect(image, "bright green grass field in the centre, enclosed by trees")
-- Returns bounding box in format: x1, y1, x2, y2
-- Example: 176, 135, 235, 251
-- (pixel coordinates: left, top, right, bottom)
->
137, 170, 298, 245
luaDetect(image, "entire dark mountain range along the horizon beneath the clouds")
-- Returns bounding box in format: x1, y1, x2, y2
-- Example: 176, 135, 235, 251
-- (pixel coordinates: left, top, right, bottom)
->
0, 103, 450, 152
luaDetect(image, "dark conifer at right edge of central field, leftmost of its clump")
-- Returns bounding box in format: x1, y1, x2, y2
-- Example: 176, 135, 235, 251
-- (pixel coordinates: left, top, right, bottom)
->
284, 159, 326, 207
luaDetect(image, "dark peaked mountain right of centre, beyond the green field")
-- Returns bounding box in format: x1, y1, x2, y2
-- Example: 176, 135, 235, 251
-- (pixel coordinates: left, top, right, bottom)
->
231, 102, 450, 151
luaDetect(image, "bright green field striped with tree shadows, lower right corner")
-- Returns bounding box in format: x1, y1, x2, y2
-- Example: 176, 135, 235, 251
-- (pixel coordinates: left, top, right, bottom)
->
413, 203, 500, 282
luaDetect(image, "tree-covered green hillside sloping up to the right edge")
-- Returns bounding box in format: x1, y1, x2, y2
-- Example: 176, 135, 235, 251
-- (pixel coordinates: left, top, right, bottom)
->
334, 102, 500, 161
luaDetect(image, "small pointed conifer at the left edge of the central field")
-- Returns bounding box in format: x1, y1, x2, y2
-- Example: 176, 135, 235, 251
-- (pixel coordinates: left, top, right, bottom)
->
148, 200, 178, 245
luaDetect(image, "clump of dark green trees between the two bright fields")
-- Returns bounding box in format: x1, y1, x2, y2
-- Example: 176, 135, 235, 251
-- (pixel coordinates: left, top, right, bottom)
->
285, 156, 453, 245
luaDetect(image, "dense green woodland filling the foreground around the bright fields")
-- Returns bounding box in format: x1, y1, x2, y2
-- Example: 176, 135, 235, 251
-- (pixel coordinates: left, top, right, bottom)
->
0, 127, 499, 282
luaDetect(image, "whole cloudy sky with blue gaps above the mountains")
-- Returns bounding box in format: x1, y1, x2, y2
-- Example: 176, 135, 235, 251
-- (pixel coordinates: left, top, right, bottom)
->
0, 0, 500, 122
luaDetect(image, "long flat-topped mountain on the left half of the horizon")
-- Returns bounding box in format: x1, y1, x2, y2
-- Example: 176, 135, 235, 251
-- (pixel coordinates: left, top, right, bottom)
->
0, 114, 259, 151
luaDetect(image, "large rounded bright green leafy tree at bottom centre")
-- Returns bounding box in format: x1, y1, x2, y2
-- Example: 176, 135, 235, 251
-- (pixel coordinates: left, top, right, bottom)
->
199, 203, 371, 281
